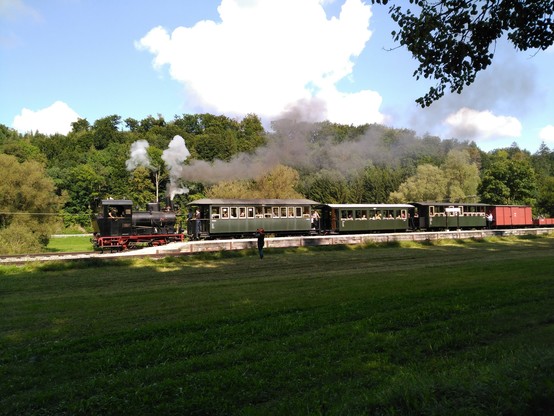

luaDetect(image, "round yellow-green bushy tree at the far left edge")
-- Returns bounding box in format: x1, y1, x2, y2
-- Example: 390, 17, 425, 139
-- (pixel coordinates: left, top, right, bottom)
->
0, 155, 63, 254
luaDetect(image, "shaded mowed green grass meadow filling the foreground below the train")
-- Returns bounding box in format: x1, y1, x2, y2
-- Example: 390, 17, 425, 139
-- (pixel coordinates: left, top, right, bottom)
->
0, 236, 554, 415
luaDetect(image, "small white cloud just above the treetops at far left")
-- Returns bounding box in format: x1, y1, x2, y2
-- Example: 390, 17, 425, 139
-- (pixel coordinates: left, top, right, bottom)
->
12, 101, 79, 134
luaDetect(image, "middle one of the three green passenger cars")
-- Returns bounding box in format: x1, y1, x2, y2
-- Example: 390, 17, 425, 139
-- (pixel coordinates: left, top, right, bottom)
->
317, 204, 414, 234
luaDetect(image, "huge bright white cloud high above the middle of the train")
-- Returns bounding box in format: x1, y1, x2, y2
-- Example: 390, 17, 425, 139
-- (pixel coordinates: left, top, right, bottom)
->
136, 0, 383, 124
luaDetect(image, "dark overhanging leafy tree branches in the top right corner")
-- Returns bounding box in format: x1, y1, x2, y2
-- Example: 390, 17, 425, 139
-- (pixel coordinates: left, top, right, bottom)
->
372, 0, 554, 107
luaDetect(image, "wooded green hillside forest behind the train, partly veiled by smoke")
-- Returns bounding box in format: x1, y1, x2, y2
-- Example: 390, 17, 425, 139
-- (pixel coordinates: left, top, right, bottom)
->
0, 114, 554, 253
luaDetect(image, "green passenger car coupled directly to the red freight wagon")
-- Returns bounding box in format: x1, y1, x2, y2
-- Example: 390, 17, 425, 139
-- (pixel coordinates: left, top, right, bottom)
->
413, 202, 488, 231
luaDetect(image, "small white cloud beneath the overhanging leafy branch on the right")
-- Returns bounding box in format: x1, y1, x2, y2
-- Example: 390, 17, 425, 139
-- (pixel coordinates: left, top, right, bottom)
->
445, 107, 521, 140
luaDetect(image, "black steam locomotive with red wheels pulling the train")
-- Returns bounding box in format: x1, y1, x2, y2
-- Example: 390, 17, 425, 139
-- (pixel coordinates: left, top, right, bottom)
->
92, 199, 184, 251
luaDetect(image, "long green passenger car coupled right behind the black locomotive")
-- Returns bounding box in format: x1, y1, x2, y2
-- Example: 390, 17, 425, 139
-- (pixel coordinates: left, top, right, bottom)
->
187, 199, 318, 239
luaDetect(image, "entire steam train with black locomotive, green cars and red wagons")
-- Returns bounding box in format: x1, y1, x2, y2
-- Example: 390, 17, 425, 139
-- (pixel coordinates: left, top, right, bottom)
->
92, 199, 554, 251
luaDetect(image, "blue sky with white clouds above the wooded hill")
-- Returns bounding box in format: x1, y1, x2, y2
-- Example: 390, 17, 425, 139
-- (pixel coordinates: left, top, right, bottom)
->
0, 0, 554, 152
